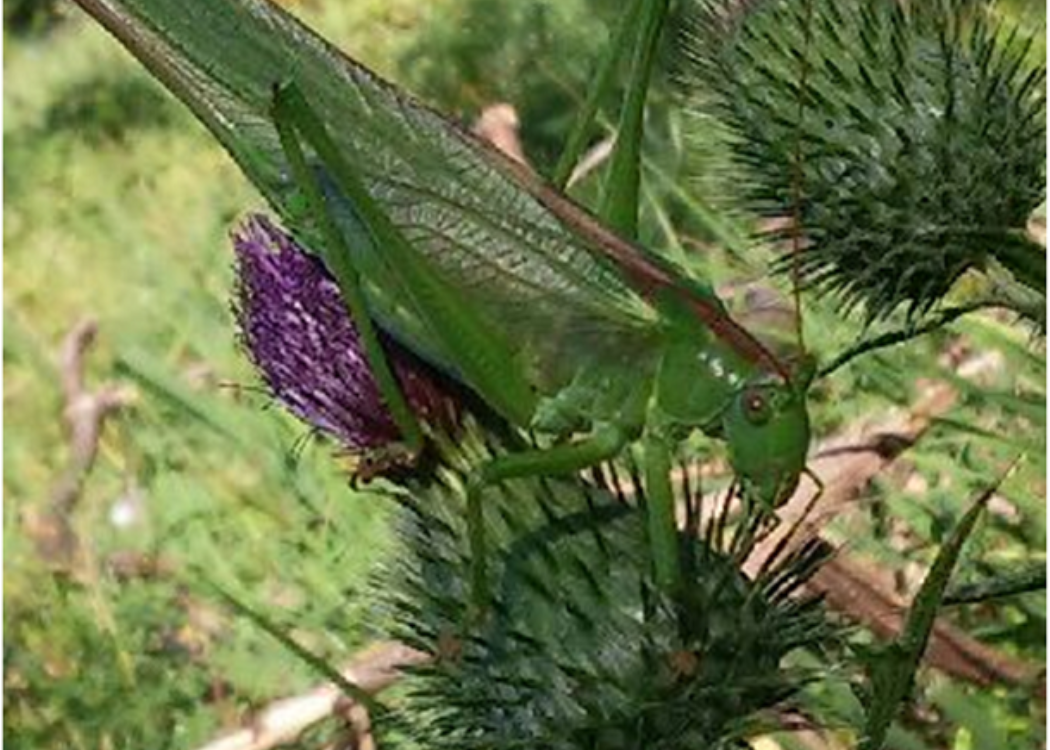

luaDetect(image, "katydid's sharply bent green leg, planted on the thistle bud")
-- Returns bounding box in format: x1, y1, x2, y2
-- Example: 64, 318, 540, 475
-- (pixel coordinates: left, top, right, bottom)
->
466, 424, 630, 617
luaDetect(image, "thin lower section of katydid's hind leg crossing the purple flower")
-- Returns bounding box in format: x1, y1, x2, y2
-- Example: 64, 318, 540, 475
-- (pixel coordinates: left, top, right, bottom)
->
272, 84, 423, 454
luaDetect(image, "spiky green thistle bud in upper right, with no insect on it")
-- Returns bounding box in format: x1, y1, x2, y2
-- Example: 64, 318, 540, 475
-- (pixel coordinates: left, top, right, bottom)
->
683, 0, 1046, 318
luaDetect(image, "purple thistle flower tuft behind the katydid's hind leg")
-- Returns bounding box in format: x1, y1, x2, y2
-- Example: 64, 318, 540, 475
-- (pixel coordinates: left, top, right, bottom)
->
233, 215, 453, 451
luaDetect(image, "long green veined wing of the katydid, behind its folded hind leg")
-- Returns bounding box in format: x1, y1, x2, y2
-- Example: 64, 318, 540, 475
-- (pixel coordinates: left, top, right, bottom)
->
86, 0, 657, 381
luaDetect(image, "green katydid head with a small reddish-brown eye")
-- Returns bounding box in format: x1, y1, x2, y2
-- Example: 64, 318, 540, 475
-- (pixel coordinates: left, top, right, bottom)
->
722, 380, 810, 508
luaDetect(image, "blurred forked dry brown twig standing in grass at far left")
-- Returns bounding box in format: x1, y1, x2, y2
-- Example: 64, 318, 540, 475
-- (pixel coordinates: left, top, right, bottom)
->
27, 318, 134, 569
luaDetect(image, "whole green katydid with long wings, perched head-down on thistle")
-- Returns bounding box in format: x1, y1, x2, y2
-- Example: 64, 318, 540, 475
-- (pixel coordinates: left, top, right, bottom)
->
78, 0, 810, 591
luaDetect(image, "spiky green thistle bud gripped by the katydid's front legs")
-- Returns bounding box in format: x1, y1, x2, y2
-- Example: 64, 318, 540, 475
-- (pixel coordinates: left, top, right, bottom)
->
380, 432, 834, 750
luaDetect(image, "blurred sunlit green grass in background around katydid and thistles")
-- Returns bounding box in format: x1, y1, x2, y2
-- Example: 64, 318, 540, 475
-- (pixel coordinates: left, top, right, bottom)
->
4, 0, 1046, 750
